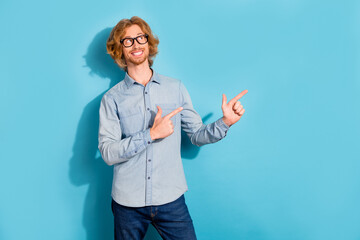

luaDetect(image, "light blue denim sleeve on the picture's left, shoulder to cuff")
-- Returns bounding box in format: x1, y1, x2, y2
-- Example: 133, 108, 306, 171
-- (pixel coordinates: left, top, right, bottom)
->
98, 94, 153, 165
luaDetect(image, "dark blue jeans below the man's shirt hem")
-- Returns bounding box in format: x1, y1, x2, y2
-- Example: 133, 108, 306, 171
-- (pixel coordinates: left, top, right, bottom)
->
111, 195, 196, 240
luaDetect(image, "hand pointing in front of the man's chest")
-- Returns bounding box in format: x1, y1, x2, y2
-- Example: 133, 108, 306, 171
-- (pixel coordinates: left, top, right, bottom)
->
150, 106, 183, 140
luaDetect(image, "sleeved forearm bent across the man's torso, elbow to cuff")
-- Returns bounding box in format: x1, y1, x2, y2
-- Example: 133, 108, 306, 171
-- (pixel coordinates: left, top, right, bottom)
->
98, 129, 152, 166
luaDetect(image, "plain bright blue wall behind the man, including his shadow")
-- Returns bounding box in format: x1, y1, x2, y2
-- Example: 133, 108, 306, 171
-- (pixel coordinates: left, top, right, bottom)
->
0, 0, 360, 240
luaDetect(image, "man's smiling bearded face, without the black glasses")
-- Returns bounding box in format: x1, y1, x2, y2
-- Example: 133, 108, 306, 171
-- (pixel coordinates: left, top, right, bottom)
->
122, 24, 149, 66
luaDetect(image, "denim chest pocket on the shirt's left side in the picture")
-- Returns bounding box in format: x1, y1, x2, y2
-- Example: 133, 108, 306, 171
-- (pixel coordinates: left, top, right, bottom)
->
119, 108, 144, 137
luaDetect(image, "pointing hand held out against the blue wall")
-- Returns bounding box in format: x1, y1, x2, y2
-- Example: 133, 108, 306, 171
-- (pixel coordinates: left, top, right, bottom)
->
221, 90, 248, 127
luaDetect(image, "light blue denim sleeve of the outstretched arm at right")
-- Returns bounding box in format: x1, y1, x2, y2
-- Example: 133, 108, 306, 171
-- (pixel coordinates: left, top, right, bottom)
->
180, 82, 229, 146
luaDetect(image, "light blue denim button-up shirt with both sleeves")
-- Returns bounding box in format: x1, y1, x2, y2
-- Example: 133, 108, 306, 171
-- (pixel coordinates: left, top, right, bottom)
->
98, 71, 229, 207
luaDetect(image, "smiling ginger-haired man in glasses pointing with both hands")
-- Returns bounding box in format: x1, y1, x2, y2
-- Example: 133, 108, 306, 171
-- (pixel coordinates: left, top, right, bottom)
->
99, 17, 247, 240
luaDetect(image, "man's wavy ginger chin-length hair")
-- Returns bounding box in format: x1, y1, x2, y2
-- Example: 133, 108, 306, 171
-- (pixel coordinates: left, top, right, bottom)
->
106, 16, 159, 71
